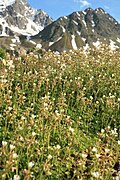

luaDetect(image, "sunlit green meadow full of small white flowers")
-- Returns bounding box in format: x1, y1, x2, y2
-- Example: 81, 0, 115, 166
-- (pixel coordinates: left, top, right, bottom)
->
0, 47, 120, 180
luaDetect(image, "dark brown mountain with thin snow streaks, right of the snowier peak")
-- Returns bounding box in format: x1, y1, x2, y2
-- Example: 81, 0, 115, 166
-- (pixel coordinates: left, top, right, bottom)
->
32, 8, 120, 51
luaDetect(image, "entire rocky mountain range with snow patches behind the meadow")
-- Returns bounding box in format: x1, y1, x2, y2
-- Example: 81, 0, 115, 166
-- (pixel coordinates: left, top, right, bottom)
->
0, 0, 120, 52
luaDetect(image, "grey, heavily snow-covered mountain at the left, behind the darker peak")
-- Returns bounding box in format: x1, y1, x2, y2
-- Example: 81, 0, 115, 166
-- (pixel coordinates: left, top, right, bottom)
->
0, 0, 53, 36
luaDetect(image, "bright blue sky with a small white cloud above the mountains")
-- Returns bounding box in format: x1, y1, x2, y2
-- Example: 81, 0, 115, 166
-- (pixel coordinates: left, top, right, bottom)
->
28, 0, 120, 22
